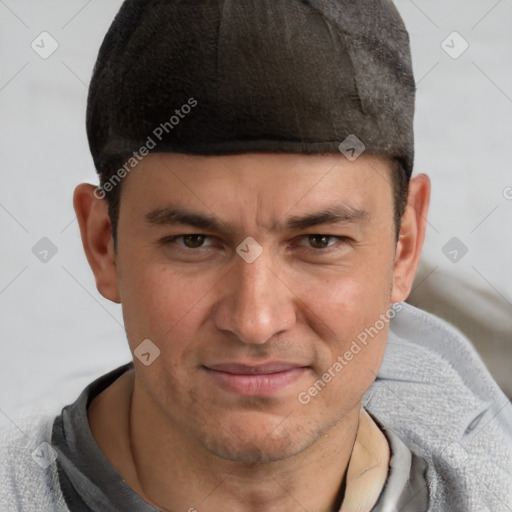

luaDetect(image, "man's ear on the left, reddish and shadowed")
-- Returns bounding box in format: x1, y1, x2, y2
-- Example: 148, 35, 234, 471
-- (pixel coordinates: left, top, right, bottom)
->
73, 183, 121, 303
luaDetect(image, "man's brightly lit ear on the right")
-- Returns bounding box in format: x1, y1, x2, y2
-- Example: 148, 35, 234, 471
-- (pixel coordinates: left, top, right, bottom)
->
391, 174, 430, 302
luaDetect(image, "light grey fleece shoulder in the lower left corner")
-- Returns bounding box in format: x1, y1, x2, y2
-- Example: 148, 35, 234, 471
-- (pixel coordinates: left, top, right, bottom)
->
0, 415, 68, 512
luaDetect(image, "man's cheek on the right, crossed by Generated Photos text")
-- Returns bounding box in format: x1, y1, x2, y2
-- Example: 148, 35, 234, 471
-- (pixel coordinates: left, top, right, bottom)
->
296, 262, 391, 404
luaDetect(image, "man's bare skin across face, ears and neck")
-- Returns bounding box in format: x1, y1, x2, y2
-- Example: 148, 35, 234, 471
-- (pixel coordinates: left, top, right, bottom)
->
74, 153, 430, 512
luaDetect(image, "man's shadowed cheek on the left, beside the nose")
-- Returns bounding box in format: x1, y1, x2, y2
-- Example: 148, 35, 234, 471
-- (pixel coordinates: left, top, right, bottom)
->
117, 263, 215, 408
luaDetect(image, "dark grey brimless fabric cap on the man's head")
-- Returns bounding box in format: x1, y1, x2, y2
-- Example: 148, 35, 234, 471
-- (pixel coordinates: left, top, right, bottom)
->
87, 0, 415, 176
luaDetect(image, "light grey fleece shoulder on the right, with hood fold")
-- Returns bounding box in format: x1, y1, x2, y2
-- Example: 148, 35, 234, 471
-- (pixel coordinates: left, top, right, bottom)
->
365, 303, 512, 512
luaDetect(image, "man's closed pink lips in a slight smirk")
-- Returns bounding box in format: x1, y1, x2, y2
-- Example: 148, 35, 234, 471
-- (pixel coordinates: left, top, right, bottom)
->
203, 361, 308, 396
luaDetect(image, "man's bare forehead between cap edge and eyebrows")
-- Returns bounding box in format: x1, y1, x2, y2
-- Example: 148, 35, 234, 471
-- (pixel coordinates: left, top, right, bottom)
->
122, 153, 393, 216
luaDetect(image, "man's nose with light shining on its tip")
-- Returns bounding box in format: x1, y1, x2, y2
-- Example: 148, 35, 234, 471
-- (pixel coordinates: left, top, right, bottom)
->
214, 244, 296, 345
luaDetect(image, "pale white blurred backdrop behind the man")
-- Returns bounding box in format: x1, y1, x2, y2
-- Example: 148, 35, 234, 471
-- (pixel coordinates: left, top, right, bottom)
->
0, 0, 512, 425
